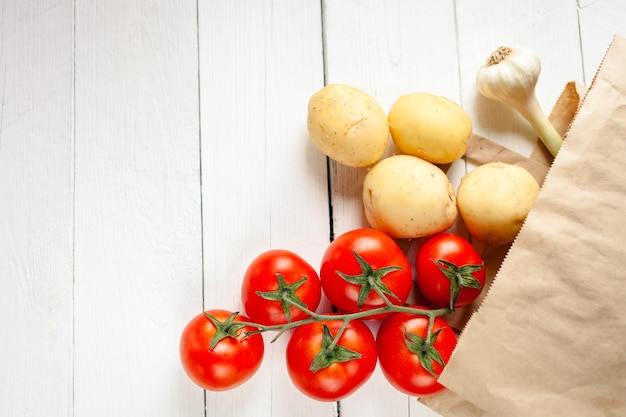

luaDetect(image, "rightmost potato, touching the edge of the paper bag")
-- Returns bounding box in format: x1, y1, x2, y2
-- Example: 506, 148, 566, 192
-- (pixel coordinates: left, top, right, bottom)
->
457, 162, 539, 245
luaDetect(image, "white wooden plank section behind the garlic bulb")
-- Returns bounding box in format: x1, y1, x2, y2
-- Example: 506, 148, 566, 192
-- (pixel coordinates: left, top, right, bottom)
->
456, 0, 583, 155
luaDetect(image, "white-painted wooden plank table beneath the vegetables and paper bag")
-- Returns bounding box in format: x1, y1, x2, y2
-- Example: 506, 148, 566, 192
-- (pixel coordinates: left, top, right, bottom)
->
0, 0, 626, 417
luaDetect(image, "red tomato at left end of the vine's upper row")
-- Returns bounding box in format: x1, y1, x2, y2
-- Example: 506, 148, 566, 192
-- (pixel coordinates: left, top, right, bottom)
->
241, 249, 322, 325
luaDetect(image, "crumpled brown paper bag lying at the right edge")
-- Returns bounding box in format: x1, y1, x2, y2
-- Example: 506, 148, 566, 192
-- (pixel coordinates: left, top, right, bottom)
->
422, 37, 626, 417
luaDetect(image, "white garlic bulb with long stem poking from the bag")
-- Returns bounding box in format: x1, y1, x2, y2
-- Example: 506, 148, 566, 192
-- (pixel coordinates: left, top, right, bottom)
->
476, 46, 563, 156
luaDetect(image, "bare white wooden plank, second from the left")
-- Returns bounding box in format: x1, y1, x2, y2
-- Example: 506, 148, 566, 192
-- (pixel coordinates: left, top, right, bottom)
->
74, 0, 204, 416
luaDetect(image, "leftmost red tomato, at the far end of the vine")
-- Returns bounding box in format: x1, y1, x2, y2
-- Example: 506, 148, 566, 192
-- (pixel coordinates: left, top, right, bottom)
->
180, 310, 265, 391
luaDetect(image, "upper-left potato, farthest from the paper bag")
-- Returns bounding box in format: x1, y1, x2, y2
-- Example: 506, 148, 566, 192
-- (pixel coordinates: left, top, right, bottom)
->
307, 84, 389, 167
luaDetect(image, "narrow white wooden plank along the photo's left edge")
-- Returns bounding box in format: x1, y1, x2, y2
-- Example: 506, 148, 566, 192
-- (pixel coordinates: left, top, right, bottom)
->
0, 1, 73, 416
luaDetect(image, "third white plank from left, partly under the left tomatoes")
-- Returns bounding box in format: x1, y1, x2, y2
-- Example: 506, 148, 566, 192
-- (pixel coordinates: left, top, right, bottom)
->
199, 0, 336, 417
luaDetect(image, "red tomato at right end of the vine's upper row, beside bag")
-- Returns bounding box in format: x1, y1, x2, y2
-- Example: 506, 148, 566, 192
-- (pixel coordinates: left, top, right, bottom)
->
415, 233, 486, 308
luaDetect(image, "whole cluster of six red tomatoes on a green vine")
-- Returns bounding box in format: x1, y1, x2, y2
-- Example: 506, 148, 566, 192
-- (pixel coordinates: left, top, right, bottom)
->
180, 228, 485, 401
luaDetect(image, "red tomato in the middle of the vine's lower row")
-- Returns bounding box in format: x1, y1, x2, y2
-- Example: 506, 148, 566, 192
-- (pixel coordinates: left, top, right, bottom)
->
287, 320, 377, 401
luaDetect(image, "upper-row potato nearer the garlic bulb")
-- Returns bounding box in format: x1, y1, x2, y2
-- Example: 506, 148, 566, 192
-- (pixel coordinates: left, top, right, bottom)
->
388, 93, 472, 164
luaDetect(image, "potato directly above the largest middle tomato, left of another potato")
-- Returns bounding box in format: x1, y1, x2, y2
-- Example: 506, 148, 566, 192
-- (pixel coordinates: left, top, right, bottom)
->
362, 155, 457, 238
